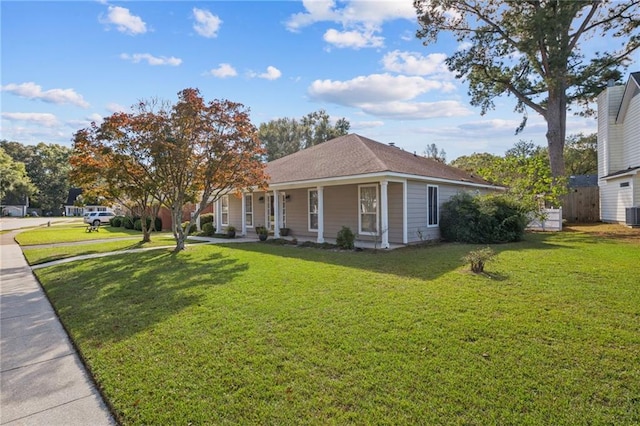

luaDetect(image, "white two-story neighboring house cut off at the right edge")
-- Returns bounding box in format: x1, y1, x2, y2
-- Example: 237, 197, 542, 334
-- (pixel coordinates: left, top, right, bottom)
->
598, 72, 640, 223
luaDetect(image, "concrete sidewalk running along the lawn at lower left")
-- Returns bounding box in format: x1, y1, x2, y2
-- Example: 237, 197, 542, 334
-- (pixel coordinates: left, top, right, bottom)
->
0, 232, 116, 426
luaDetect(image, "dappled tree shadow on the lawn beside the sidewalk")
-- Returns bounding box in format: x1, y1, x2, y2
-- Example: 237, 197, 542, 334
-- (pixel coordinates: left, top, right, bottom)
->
36, 250, 248, 345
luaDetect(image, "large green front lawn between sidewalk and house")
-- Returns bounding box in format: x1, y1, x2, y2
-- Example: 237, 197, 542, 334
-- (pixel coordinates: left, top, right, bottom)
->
36, 232, 640, 425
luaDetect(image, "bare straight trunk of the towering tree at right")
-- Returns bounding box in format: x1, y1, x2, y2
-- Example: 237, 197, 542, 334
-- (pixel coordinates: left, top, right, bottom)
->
545, 90, 567, 180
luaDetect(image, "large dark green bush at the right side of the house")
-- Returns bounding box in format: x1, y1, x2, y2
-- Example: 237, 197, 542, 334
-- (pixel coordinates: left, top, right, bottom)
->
440, 193, 528, 244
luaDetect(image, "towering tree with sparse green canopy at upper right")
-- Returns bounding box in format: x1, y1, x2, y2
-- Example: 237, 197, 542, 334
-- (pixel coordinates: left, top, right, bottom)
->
414, 0, 640, 177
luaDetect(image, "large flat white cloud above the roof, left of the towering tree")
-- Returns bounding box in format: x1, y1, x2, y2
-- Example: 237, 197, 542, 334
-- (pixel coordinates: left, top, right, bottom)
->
308, 74, 455, 106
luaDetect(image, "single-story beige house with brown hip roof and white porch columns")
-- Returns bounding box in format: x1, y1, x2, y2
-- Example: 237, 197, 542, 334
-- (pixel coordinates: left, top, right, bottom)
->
208, 134, 502, 248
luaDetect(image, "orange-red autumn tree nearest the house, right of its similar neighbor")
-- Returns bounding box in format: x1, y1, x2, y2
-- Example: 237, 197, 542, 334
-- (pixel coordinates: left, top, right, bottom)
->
159, 89, 266, 251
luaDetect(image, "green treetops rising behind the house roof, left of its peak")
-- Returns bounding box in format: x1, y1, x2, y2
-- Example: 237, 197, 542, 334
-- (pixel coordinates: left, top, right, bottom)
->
258, 110, 351, 161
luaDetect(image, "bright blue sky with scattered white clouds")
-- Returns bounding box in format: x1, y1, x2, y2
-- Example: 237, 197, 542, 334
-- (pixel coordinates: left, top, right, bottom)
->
0, 0, 640, 160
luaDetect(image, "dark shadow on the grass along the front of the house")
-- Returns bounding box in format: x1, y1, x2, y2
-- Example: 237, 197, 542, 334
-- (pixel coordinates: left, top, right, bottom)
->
220, 234, 564, 281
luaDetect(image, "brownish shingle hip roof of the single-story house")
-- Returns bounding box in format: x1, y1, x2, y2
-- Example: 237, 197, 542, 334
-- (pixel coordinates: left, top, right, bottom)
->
267, 133, 489, 185
